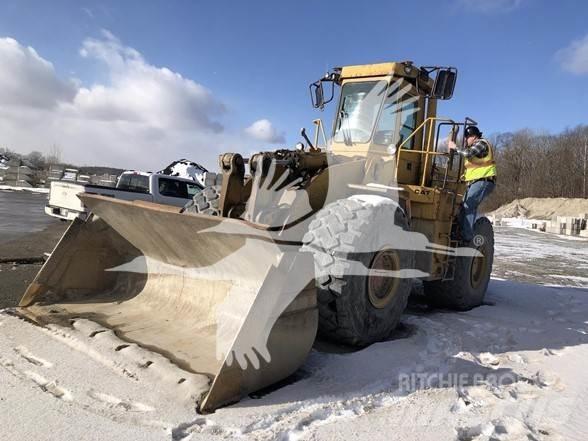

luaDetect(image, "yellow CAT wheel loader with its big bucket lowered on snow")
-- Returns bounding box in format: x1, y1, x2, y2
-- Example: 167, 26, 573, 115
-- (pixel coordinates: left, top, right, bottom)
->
18, 61, 493, 412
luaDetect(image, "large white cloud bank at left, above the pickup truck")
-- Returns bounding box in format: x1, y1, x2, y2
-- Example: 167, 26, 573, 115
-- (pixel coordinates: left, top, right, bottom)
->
0, 31, 254, 170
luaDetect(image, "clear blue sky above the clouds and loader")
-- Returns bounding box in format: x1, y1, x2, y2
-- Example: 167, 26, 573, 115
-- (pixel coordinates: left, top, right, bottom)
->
0, 0, 588, 168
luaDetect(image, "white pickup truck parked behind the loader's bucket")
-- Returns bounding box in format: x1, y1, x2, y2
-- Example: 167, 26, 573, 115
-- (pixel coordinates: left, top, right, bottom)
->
45, 171, 203, 220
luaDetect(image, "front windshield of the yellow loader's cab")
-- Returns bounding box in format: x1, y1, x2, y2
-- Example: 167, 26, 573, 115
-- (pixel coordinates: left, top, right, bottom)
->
333, 81, 387, 145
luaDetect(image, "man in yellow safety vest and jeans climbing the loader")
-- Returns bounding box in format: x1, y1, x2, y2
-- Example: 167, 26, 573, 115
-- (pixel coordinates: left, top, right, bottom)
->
447, 126, 496, 242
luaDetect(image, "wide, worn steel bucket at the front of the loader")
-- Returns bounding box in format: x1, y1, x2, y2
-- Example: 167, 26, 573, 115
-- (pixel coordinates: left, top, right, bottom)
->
19, 195, 318, 412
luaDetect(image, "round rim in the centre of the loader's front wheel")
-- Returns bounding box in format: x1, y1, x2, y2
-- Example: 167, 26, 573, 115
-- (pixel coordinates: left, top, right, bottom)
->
367, 250, 400, 309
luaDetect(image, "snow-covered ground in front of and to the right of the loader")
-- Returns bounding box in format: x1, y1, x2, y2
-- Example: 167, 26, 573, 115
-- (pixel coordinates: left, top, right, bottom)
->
0, 227, 588, 441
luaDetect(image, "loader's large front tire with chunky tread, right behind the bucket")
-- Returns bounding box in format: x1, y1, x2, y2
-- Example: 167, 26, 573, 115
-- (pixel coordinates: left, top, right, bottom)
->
302, 199, 414, 346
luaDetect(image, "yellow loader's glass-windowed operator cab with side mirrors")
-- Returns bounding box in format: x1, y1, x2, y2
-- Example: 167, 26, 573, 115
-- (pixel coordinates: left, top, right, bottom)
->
311, 62, 456, 184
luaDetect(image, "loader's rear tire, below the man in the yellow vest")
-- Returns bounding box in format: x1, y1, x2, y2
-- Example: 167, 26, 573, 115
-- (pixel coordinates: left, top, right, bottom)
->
423, 217, 494, 311
